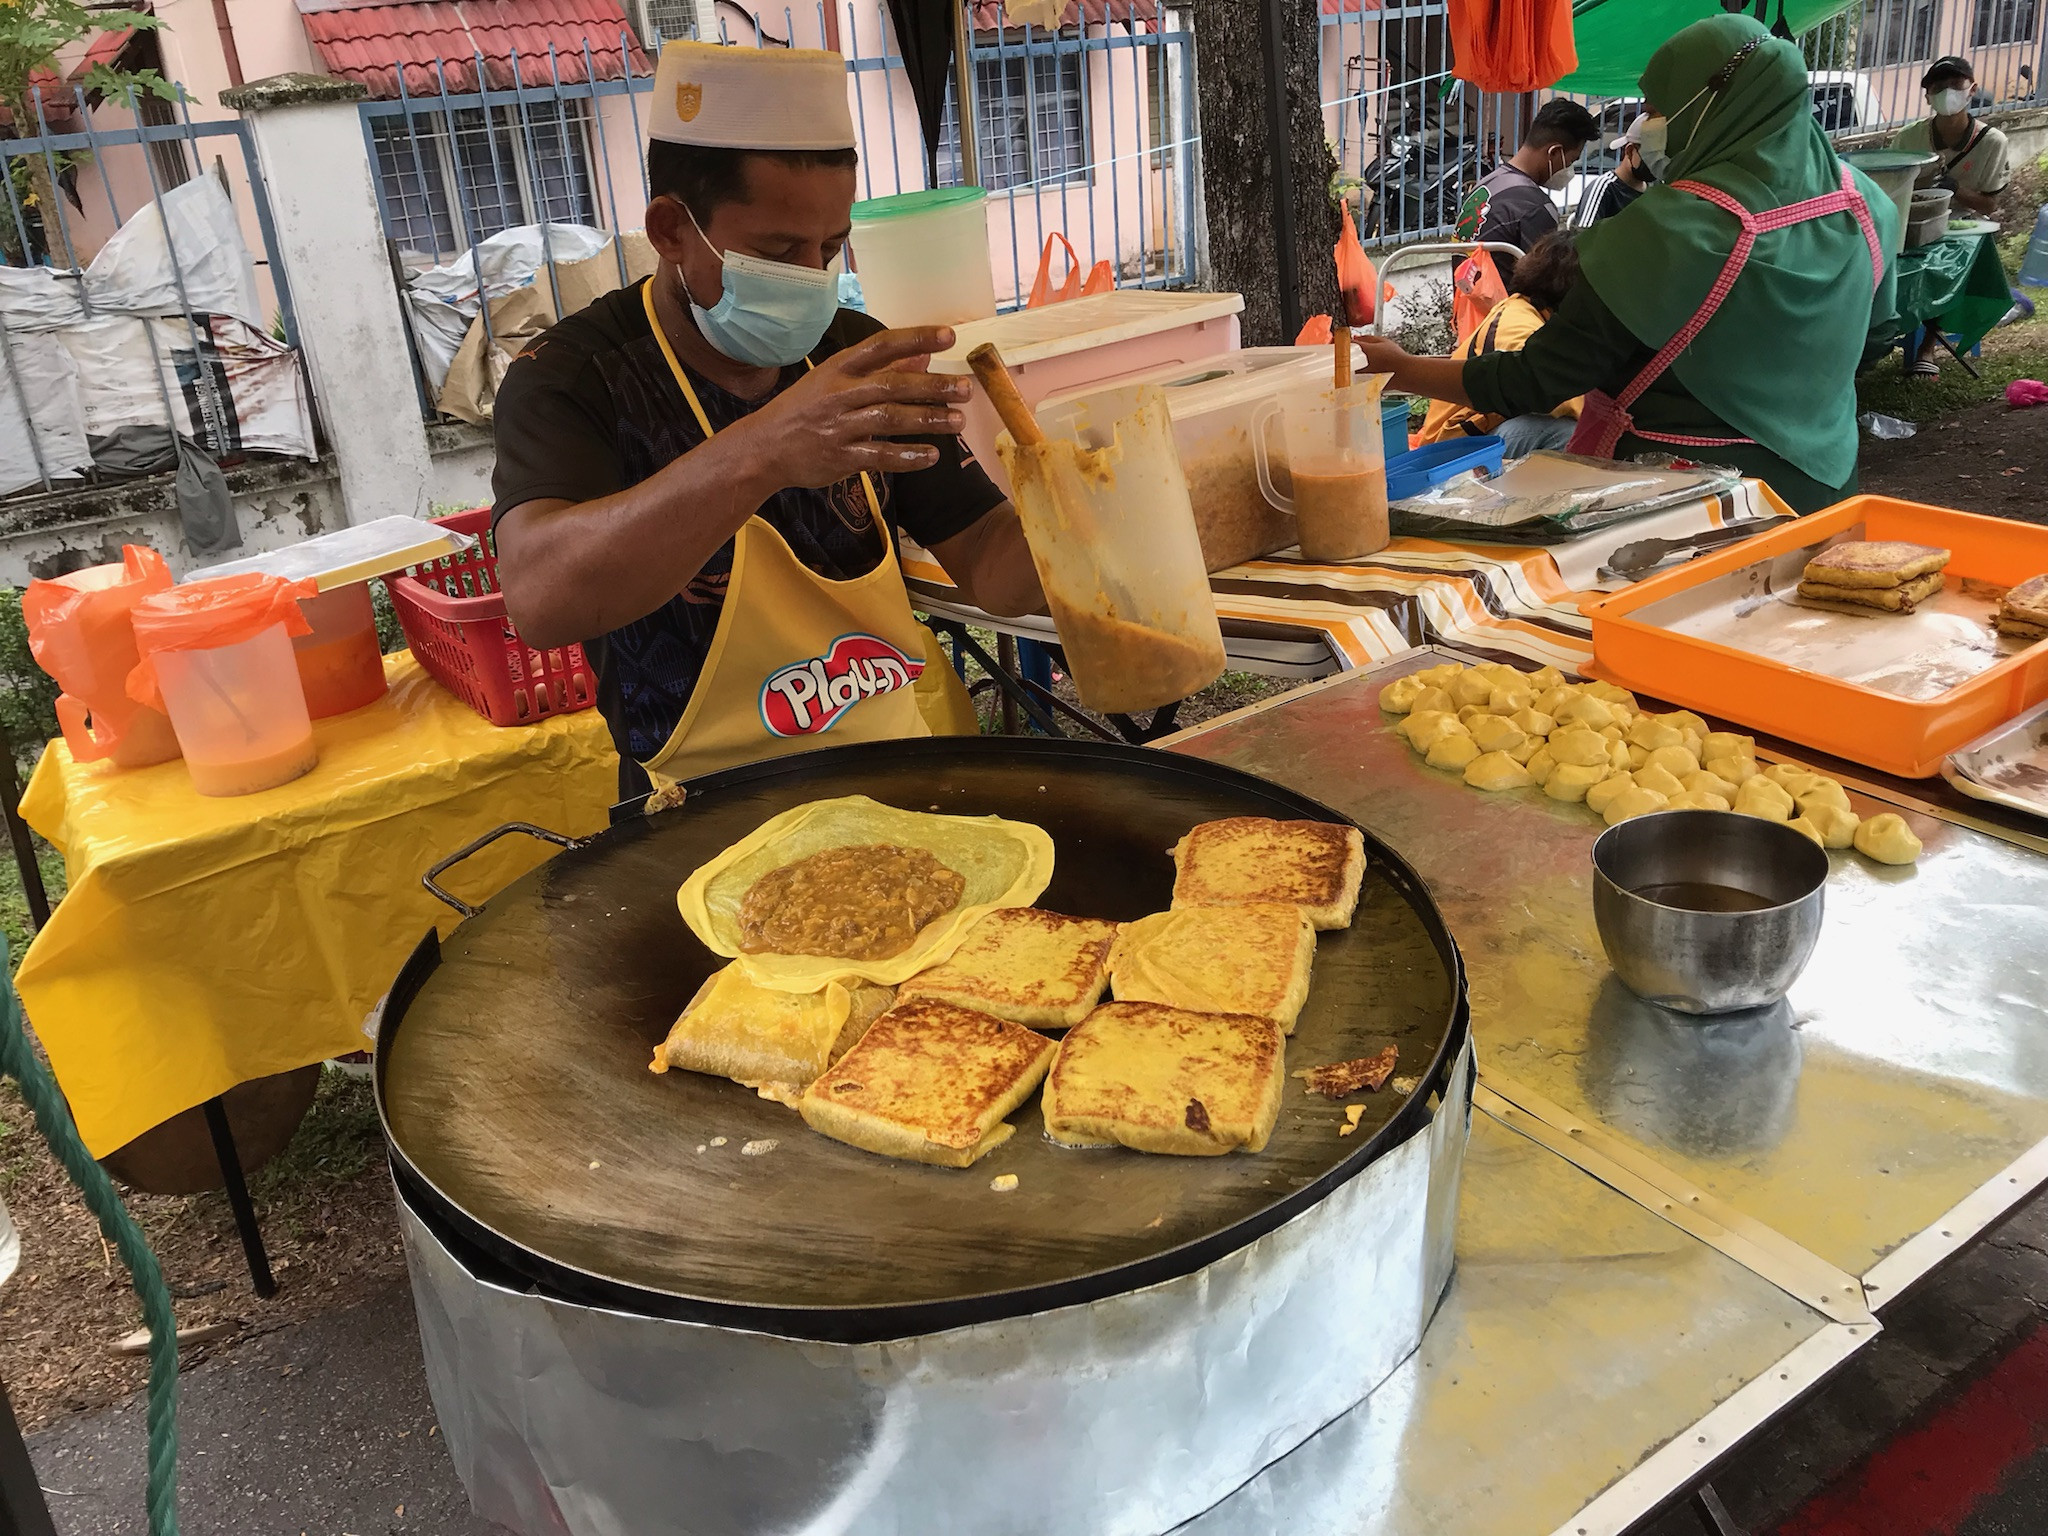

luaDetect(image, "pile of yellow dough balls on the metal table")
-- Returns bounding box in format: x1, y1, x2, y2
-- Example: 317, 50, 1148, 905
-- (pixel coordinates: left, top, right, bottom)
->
1380, 662, 1921, 864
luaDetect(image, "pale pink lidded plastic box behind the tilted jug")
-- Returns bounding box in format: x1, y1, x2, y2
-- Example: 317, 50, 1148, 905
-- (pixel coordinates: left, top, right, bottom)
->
932, 289, 1245, 492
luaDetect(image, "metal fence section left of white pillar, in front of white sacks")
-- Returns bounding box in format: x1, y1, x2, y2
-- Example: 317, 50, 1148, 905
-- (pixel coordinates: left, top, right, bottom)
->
0, 86, 317, 494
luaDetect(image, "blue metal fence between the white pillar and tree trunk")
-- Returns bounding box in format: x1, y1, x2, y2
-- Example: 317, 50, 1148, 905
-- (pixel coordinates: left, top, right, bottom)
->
360, 0, 1200, 414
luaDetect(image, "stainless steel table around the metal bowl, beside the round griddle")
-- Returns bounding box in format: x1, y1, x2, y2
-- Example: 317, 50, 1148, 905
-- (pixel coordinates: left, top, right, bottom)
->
1165, 651, 2048, 1536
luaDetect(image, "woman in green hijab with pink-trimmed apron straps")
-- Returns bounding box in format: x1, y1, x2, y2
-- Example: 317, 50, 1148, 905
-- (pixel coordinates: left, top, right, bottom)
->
1366, 16, 1898, 512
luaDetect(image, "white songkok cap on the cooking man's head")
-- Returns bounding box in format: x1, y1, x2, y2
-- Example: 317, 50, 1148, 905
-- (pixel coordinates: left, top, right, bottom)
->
647, 43, 854, 150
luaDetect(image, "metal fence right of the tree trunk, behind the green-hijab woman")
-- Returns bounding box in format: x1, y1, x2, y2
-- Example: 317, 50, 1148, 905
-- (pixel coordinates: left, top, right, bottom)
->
1327, 0, 2048, 246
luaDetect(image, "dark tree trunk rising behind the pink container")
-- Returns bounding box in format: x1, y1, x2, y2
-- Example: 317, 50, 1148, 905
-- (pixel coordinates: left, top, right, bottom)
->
1194, 0, 1341, 346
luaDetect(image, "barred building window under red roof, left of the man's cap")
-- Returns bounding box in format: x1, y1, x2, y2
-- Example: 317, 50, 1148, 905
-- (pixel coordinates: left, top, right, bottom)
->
371, 102, 598, 256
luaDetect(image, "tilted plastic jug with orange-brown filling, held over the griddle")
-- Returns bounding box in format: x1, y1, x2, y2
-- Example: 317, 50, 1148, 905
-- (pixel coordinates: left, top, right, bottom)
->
995, 389, 1223, 715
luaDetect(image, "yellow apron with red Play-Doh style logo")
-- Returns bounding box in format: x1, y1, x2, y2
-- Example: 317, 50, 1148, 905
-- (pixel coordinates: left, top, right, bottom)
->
641, 285, 981, 788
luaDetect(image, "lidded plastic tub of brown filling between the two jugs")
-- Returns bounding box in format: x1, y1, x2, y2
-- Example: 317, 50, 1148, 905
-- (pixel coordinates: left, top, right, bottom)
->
1038, 346, 1364, 571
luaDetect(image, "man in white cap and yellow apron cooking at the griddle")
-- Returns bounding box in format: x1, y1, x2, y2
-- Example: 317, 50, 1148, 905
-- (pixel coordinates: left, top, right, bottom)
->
492, 43, 1042, 795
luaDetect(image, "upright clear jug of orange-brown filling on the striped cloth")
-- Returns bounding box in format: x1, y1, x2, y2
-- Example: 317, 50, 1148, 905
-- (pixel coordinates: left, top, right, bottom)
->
1251, 373, 1391, 561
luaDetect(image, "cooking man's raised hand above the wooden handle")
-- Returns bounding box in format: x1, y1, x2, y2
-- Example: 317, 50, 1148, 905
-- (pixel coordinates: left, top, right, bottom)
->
727, 326, 969, 489
